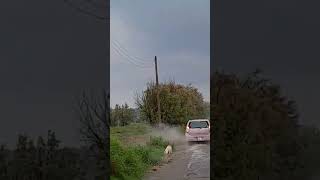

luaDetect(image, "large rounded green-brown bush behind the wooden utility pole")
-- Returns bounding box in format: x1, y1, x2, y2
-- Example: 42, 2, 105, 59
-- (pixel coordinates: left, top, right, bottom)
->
136, 82, 208, 124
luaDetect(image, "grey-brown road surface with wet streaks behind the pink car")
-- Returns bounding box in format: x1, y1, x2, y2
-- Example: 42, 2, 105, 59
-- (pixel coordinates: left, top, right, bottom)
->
144, 142, 210, 180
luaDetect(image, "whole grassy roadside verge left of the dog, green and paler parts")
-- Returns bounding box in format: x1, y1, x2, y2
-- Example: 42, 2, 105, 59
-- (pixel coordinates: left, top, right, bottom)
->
110, 123, 168, 180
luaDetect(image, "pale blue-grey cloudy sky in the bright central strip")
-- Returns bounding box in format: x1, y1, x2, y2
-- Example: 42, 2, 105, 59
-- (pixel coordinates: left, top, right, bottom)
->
110, 0, 210, 107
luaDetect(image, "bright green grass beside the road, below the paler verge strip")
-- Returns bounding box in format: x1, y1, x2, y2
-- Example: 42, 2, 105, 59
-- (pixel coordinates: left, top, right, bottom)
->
110, 132, 168, 180
